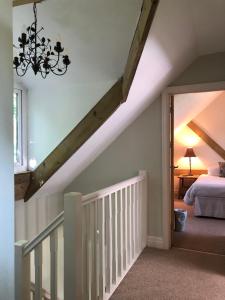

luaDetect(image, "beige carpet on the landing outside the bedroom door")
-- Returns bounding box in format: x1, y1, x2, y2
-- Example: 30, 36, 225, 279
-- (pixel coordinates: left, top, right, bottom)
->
110, 248, 225, 300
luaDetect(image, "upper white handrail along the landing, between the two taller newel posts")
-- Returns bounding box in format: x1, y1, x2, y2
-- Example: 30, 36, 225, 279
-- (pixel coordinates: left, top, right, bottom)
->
82, 175, 144, 205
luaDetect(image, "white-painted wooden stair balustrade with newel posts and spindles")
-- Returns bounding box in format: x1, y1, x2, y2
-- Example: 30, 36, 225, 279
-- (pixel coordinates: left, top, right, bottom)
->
15, 171, 147, 300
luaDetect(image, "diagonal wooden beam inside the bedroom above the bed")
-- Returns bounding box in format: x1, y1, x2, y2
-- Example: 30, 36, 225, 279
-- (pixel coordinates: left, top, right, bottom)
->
187, 121, 225, 160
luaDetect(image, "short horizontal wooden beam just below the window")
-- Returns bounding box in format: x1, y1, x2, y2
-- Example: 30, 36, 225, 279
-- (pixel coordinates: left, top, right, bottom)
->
14, 172, 31, 200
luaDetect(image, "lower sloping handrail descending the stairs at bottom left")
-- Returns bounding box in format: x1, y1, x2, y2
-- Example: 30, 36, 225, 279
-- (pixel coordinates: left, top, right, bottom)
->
23, 211, 64, 256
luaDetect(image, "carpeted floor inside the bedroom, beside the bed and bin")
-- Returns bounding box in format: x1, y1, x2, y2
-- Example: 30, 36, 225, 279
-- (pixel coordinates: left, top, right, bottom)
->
173, 200, 225, 255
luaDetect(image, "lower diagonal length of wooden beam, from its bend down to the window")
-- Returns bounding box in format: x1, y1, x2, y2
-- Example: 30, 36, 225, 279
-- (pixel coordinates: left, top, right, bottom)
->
24, 78, 123, 201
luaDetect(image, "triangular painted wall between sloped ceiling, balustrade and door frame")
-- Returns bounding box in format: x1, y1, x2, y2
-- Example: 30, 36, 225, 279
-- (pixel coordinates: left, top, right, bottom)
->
66, 98, 162, 236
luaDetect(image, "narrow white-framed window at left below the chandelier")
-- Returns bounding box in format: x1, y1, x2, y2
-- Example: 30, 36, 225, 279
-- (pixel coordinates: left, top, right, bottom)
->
13, 89, 26, 171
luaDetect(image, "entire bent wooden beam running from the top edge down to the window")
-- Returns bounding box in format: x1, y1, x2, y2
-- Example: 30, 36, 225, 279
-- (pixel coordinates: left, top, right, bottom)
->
24, 0, 159, 201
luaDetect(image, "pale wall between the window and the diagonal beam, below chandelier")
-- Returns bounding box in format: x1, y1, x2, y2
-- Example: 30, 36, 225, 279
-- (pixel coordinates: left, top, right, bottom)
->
28, 81, 114, 165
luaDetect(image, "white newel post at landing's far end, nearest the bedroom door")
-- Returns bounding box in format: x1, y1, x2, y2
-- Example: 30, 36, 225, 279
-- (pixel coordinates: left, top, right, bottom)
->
139, 170, 149, 247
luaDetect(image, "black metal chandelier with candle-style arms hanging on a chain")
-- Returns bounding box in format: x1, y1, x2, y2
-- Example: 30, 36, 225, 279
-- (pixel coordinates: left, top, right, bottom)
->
13, 3, 70, 78
